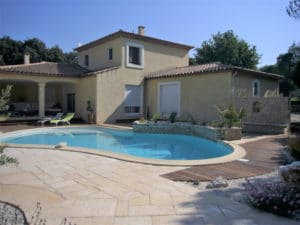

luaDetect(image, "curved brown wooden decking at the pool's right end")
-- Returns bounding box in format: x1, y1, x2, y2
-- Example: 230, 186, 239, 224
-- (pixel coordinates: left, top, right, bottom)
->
162, 136, 287, 182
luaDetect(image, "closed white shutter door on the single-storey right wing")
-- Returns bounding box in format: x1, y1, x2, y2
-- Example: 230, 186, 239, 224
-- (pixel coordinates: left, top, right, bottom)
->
158, 82, 180, 116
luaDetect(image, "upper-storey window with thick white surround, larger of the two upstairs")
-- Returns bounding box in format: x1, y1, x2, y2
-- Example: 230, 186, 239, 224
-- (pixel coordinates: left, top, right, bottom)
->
126, 43, 144, 68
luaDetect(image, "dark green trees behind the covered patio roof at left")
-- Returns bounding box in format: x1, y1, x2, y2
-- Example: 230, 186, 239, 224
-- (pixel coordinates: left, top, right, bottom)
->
0, 36, 78, 65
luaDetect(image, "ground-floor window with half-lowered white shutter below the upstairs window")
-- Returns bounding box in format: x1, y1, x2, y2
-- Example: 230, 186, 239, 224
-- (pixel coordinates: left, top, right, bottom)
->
124, 85, 142, 113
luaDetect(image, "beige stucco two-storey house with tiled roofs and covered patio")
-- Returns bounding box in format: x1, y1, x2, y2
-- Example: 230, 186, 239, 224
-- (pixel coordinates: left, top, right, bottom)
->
0, 26, 288, 132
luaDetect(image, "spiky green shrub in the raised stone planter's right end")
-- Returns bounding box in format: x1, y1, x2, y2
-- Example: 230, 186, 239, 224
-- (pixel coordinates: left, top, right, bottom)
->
217, 104, 246, 128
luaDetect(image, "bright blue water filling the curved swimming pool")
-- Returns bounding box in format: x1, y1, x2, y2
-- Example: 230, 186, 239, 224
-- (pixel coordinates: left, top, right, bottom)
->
0, 127, 233, 160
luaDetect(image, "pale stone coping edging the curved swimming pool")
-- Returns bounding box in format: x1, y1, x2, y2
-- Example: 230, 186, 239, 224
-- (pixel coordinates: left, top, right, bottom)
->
0, 125, 246, 166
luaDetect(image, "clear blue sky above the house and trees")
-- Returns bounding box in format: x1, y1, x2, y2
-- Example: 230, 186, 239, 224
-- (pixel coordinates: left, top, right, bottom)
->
0, 0, 300, 66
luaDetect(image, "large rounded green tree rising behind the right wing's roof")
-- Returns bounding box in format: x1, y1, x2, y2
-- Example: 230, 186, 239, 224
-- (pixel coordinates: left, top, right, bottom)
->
194, 30, 260, 69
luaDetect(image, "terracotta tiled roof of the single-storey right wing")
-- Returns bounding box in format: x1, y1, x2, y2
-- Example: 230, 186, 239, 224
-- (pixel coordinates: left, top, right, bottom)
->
145, 62, 282, 80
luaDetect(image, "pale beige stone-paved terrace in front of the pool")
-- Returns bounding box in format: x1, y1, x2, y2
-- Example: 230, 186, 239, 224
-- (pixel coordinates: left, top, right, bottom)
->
0, 125, 298, 225
